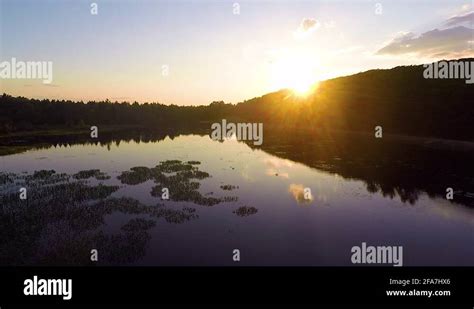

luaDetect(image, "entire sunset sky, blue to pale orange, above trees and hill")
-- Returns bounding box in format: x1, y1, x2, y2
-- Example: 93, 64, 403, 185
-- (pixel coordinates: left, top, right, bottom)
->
0, 0, 474, 105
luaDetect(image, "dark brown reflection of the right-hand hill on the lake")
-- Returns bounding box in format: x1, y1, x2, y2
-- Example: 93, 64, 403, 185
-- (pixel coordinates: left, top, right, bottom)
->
248, 126, 474, 207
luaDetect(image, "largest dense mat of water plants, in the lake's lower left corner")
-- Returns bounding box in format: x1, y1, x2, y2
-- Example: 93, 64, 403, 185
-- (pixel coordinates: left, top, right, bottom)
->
0, 170, 198, 266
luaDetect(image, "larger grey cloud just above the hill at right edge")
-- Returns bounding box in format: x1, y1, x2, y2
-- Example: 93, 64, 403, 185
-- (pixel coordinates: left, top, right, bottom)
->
376, 26, 474, 58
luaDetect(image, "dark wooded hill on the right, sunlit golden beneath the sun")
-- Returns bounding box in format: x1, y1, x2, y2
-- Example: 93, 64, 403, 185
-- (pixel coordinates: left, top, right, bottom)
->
236, 59, 474, 140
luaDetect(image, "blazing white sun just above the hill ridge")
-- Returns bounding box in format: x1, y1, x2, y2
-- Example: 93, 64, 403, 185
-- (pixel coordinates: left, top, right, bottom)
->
271, 51, 317, 96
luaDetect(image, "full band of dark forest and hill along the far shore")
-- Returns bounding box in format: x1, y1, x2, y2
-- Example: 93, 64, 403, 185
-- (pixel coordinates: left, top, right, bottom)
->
0, 59, 474, 141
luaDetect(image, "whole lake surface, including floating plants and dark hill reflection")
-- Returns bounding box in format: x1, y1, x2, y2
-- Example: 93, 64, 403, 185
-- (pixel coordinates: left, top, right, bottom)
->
0, 130, 474, 266
